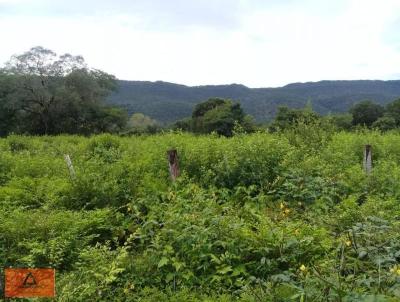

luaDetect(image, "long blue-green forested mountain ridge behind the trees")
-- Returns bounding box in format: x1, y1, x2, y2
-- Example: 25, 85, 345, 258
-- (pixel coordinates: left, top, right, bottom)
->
109, 80, 400, 123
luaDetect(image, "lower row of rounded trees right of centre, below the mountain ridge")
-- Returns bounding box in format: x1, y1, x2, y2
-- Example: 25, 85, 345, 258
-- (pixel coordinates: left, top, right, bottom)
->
174, 98, 400, 136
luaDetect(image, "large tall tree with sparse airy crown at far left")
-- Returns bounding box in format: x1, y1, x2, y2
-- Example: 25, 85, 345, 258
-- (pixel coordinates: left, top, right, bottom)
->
0, 47, 126, 134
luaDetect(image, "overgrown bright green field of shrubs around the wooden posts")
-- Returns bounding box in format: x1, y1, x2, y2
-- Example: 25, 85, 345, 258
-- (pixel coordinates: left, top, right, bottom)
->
0, 129, 400, 302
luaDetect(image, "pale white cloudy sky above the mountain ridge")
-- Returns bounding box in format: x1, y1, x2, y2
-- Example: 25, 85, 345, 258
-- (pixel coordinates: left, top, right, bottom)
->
0, 0, 400, 87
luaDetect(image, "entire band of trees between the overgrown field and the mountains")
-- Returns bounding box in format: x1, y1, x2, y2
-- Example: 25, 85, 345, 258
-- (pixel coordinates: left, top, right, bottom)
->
0, 47, 400, 137
